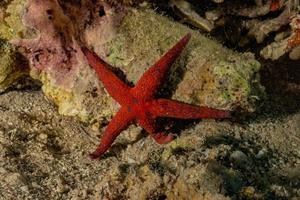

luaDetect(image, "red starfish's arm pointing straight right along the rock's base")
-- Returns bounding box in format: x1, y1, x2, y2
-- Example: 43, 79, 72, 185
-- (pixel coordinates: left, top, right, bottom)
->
149, 99, 230, 119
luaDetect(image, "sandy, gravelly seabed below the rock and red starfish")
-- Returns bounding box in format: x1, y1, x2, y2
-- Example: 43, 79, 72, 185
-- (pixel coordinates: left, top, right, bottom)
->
0, 74, 300, 200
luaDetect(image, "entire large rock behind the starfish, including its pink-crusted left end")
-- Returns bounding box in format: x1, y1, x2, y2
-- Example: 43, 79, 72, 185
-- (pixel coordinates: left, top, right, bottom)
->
2, 0, 263, 121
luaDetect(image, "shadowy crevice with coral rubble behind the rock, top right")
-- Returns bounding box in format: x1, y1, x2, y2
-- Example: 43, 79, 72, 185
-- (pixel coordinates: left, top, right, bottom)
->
170, 0, 300, 60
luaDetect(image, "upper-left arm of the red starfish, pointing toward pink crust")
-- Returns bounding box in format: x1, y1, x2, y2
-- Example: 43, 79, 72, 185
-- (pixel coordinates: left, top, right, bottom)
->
81, 47, 130, 104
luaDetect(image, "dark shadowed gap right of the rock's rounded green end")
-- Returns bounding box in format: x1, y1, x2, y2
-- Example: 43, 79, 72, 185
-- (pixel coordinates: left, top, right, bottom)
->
237, 56, 300, 122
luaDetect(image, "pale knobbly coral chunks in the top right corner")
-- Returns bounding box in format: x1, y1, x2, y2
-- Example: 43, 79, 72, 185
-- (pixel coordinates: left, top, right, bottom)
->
237, 0, 300, 60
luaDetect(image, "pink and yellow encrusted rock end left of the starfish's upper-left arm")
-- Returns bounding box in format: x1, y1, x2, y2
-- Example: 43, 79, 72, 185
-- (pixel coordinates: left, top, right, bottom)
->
12, 0, 125, 121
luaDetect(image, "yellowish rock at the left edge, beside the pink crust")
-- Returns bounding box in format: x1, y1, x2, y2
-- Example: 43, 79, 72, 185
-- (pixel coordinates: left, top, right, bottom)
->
0, 0, 29, 93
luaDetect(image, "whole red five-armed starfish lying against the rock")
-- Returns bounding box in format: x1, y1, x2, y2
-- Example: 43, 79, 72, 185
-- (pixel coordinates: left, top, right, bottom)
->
82, 34, 230, 159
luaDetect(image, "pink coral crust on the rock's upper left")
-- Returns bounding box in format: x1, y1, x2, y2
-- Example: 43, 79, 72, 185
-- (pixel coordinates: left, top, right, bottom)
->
13, 0, 123, 89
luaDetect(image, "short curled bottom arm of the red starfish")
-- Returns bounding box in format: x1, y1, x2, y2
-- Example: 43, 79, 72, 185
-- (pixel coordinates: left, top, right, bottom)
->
137, 117, 173, 144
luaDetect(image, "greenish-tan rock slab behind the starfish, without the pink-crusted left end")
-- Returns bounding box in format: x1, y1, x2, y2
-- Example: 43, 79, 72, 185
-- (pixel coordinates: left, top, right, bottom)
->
98, 11, 263, 112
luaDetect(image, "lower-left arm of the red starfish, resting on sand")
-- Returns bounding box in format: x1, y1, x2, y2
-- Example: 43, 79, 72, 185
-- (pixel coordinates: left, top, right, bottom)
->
90, 108, 134, 159
